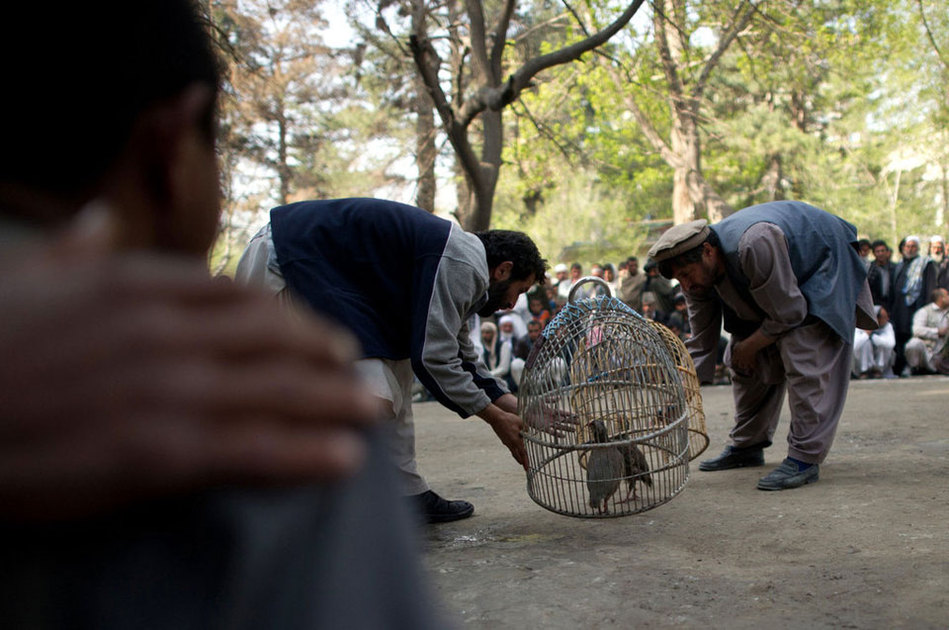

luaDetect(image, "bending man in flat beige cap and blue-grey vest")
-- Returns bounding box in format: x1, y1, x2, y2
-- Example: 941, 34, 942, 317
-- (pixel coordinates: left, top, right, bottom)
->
649, 201, 877, 490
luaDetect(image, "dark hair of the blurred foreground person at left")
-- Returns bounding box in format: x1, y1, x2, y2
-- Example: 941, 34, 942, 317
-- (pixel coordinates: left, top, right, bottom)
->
0, 0, 219, 194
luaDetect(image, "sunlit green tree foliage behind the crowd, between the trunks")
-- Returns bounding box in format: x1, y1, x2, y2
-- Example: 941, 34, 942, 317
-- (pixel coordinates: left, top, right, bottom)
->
214, 0, 949, 272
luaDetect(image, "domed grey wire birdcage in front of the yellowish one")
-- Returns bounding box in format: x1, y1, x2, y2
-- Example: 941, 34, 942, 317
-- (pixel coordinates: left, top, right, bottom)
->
518, 278, 691, 518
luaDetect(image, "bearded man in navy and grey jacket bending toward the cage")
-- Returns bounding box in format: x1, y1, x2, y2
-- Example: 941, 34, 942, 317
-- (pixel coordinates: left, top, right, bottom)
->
237, 199, 547, 522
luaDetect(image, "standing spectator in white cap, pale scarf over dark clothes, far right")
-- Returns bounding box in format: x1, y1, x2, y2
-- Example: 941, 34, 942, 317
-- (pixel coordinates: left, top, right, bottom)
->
890, 235, 936, 376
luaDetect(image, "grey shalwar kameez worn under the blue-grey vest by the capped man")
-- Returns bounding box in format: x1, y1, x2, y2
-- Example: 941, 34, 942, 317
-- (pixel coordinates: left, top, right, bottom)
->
687, 221, 873, 464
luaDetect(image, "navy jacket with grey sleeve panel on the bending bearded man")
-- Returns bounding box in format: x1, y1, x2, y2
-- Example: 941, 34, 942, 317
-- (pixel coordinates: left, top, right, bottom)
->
270, 199, 507, 416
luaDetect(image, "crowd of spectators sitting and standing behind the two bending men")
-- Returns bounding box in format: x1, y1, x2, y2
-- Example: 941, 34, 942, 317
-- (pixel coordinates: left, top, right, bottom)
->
415, 234, 949, 400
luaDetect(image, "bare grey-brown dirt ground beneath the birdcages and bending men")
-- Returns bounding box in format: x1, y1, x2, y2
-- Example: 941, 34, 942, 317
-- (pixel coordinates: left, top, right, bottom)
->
415, 377, 949, 629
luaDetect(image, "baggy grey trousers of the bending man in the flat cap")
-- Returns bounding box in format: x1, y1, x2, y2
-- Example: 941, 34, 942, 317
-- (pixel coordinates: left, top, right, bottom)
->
725, 321, 853, 464
